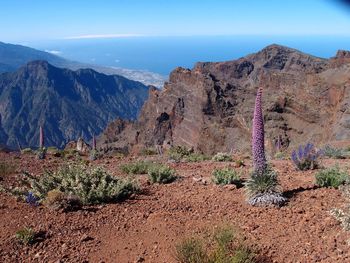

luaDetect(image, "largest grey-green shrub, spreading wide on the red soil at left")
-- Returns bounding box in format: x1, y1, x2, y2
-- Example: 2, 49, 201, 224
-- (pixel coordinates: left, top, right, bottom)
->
20, 165, 138, 204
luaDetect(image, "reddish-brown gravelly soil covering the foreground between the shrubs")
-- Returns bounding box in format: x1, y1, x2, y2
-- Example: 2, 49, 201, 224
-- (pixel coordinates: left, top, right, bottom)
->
0, 153, 350, 263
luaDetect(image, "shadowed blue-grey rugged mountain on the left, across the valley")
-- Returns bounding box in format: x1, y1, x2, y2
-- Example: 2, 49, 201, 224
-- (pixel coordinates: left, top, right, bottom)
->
0, 61, 148, 150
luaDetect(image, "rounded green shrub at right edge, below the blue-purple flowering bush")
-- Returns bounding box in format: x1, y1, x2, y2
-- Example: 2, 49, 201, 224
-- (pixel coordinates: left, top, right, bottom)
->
315, 165, 349, 188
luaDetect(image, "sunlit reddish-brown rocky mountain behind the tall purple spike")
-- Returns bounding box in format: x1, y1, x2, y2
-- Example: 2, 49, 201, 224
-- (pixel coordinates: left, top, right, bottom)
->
99, 45, 350, 153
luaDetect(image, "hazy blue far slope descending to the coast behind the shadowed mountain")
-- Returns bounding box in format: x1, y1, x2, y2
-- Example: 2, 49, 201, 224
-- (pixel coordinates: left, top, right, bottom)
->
0, 42, 166, 88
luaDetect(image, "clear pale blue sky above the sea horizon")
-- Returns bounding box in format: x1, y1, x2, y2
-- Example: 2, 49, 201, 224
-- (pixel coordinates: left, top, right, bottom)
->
0, 0, 350, 42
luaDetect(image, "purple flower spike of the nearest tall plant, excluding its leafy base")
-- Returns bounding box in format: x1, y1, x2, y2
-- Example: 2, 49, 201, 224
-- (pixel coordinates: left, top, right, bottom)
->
252, 88, 266, 172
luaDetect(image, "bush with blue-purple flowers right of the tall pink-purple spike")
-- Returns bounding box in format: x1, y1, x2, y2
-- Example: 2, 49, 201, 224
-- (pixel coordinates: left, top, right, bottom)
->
291, 143, 322, 171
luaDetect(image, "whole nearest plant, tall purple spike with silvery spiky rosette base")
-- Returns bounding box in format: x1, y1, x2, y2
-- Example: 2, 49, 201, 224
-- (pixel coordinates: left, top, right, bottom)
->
245, 88, 286, 206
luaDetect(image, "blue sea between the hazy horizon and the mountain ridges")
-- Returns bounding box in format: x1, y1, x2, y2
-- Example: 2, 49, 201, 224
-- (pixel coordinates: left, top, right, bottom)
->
26, 35, 350, 76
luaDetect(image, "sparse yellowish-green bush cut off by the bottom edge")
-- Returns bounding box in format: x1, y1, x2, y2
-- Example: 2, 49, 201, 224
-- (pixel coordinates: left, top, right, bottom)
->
175, 227, 254, 263
